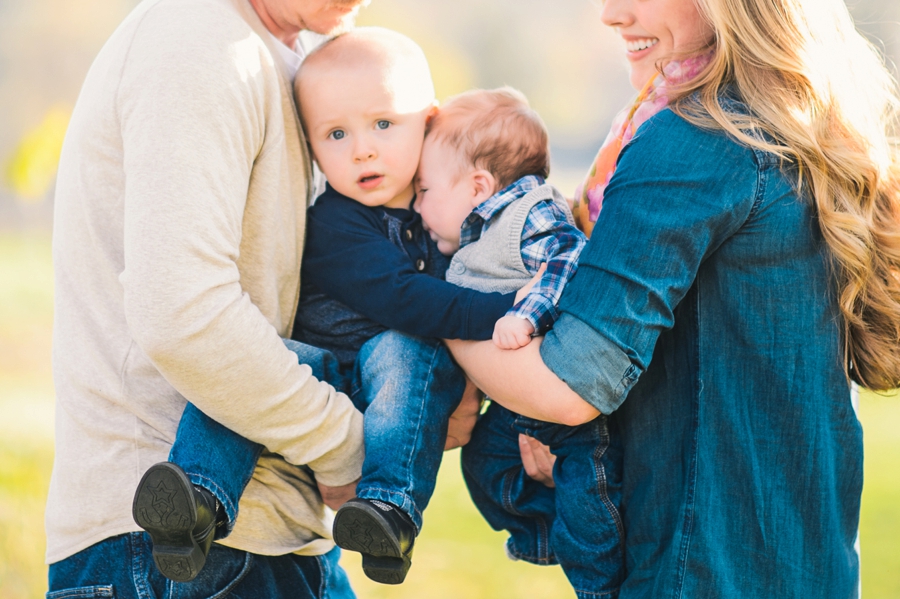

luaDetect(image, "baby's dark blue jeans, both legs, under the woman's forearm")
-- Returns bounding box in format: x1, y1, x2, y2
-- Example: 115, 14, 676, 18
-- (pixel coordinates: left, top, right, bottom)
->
462, 403, 625, 599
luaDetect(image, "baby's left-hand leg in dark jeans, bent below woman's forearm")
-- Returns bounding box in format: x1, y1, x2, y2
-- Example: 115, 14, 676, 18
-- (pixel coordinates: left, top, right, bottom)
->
462, 403, 556, 565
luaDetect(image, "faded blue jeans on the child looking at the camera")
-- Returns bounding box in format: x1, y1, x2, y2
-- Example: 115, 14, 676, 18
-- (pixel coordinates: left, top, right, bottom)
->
169, 331, 465, 538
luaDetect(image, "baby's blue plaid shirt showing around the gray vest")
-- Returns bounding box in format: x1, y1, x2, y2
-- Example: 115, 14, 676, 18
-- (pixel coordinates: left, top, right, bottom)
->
459, 175, 587, 335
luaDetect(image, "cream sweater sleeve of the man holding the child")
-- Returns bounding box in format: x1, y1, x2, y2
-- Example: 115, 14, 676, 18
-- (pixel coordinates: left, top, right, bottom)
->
117, 9, 363, 485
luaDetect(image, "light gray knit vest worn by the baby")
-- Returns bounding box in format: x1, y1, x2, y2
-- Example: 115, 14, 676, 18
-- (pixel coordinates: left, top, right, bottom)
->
446, 183, 575, 293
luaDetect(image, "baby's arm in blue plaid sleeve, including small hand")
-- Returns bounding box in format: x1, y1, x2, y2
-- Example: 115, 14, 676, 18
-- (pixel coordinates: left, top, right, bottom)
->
493, 202, 587, 349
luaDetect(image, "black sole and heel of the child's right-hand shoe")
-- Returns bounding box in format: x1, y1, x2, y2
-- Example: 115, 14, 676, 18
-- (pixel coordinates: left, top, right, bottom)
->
333, 503, 412, 584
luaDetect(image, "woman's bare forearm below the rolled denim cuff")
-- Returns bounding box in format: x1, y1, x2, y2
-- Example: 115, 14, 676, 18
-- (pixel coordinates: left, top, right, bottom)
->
446, 338, 600, 426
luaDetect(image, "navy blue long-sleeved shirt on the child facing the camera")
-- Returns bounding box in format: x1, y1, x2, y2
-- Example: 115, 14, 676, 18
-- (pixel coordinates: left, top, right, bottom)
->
292, 186, 515, 367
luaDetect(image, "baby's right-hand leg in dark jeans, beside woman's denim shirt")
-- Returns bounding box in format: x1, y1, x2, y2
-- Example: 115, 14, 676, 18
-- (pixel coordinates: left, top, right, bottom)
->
516, 416, 625, 599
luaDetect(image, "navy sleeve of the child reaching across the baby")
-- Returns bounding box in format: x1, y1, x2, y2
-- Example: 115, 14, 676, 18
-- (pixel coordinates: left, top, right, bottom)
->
303, 200, 515, 340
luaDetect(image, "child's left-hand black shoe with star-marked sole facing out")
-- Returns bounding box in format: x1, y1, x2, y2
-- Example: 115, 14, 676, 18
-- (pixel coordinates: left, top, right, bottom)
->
131, 462, 217, 582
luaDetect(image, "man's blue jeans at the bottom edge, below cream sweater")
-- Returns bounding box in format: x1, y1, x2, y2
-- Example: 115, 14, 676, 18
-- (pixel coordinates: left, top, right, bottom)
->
47, 532, 355, 599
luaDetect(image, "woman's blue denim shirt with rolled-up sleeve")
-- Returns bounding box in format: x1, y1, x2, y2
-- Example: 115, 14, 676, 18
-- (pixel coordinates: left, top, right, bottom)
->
541, 110, 863, 599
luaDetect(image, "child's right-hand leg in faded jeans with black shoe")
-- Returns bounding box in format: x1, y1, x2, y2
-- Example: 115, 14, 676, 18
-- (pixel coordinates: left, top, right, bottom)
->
334, 331, 465, 584
